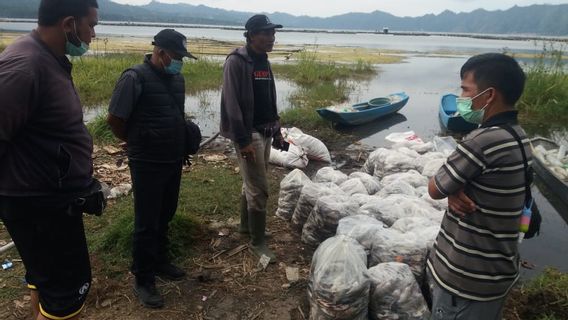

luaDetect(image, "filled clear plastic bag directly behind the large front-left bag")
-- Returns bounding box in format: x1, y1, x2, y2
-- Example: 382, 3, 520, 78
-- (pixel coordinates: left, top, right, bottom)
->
302, 195, 359, 247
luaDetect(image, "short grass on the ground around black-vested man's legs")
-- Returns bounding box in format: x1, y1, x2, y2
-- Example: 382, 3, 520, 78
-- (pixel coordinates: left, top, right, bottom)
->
85, 160, 279, 277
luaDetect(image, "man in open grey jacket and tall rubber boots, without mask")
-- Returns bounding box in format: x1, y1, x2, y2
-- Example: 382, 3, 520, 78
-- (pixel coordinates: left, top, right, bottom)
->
221, 14, 282, 262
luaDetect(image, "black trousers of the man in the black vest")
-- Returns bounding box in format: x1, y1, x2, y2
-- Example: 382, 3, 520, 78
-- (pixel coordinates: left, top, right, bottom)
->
130, 161, 182, 284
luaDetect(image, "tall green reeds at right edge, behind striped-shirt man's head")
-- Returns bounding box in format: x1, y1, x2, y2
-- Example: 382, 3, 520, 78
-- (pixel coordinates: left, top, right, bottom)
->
517, 47, 568, 131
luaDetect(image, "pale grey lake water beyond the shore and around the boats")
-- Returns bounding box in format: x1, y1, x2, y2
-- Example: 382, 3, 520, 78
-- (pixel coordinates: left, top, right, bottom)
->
0, 22, 568, 276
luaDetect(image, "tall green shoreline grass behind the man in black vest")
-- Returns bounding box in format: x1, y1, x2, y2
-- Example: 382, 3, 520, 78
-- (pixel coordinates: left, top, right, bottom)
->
73, 53, 223, 107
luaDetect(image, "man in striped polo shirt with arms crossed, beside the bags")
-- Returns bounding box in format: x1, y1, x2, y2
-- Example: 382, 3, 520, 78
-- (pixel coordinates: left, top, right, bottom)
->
427, 53, 531, 320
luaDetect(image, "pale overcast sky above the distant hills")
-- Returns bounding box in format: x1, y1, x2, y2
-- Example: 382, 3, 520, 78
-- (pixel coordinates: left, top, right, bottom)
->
112, 0, 568, 17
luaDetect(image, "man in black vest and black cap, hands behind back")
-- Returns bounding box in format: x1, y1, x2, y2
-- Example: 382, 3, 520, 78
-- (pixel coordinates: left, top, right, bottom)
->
108, 29, 196, 308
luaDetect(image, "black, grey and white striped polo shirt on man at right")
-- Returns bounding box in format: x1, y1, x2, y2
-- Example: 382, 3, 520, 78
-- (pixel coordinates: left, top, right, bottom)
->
427, 111, 532, 301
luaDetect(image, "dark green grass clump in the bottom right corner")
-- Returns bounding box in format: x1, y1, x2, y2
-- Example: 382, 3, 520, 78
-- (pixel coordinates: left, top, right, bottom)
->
505, 269, 568, 320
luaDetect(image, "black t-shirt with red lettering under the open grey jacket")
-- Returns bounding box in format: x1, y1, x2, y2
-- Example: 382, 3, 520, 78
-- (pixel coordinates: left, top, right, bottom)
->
247, 47, 278, 127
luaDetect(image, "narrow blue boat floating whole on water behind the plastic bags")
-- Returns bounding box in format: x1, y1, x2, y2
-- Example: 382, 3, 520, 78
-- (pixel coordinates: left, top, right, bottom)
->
316, 92, 408, 125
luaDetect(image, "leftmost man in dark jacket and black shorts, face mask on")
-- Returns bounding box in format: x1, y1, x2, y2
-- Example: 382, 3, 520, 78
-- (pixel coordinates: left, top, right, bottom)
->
0, 0, 98, 320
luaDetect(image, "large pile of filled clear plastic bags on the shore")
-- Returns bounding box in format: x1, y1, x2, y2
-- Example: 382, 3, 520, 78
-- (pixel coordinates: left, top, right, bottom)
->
272, 132, 456, 319
